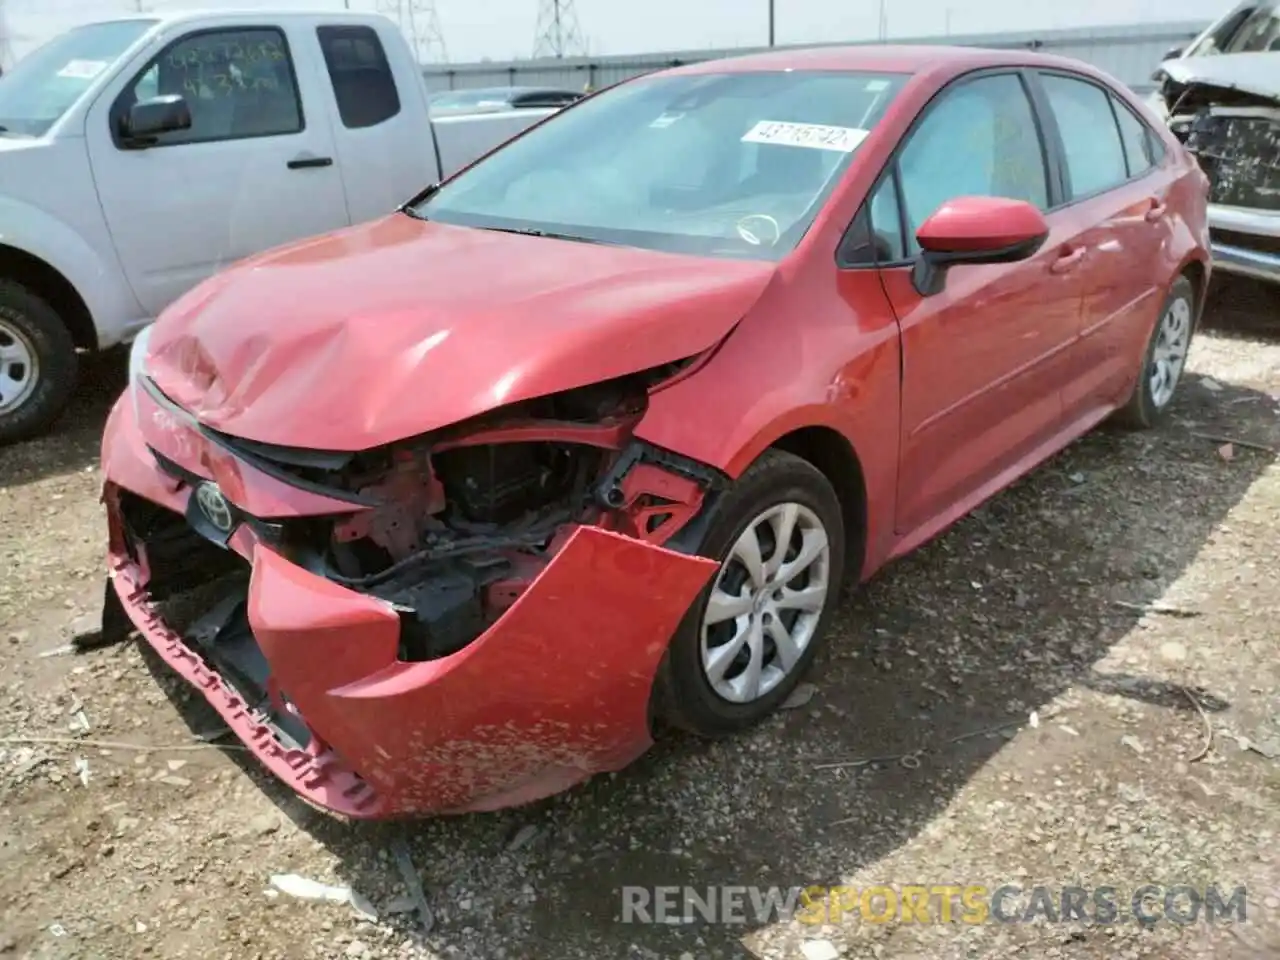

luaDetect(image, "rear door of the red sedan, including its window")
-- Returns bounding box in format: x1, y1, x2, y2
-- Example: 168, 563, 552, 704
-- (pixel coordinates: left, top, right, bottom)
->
1037, 72, 1175, 419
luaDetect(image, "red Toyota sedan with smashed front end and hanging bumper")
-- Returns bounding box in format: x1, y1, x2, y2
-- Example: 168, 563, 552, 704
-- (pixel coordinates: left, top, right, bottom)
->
102, 46, 1210, 818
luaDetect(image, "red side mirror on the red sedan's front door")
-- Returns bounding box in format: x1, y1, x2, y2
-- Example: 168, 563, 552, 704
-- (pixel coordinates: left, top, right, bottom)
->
911, 197, 1048, 297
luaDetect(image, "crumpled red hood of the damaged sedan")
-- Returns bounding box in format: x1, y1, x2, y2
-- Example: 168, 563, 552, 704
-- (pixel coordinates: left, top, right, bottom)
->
146, 214, 776, 451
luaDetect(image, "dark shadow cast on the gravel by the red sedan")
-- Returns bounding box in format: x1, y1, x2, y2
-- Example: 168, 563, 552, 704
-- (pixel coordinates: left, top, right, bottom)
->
135, 343, 1280, 957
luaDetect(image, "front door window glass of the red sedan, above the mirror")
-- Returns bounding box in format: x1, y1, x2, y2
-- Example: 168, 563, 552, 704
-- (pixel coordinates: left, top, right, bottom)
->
899, 73, 1048, 253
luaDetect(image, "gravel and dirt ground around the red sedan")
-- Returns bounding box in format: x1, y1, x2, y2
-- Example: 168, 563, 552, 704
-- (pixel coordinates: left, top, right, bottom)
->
0, 277, 1280, 960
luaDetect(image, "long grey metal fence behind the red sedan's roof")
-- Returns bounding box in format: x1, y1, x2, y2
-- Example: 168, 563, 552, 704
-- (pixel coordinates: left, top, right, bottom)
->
422, 22, 1208, 92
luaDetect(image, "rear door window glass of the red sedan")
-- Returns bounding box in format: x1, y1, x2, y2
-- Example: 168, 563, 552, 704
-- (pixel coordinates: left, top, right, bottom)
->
1042, 74, 1129, 197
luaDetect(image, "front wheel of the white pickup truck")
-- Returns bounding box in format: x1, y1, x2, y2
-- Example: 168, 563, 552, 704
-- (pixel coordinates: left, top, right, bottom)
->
0, 280, 77, 444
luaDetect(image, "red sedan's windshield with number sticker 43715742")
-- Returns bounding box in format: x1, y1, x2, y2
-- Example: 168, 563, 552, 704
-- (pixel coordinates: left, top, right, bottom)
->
408, 72, 906, 260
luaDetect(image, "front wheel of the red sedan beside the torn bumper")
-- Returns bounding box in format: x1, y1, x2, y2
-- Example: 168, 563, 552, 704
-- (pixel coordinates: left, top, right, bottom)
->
654, 451, 845, 736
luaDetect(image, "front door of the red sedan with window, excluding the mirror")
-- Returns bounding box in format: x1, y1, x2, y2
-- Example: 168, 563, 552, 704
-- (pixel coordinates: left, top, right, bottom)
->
872, 70, 1082, 541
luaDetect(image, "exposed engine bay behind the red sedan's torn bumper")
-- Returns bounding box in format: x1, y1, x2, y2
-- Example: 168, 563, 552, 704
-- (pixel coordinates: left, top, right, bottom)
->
135, 361, 726, 660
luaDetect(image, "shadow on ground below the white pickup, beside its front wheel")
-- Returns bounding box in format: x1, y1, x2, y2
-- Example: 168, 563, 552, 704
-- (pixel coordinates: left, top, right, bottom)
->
0, 349, 129, 486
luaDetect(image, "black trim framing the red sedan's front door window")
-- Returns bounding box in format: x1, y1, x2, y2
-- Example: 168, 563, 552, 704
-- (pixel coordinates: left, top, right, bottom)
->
836, 65, 1054, 270
